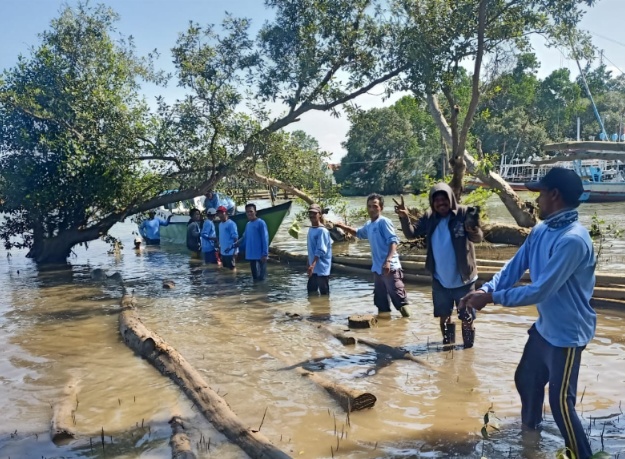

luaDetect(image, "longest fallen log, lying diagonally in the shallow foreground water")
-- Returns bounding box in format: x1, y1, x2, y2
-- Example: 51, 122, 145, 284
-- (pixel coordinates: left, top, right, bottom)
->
119, 308, 290, 459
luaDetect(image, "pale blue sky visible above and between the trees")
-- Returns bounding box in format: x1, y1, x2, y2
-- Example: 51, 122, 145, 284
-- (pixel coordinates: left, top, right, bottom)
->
0, 0, 625, 162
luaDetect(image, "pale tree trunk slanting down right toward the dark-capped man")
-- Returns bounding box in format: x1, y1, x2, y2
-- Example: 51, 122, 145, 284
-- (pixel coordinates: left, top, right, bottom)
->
427, 94, 536, 228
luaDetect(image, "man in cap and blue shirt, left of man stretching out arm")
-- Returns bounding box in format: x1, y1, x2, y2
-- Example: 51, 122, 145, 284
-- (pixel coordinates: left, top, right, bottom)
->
306, 204, 332, 295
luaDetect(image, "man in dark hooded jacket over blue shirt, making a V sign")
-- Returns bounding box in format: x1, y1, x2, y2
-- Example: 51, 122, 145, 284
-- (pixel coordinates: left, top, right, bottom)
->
395, 183, 483, 348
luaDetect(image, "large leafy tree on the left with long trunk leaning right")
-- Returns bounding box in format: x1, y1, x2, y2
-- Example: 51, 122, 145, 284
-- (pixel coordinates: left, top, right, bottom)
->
0, 0, 407, 263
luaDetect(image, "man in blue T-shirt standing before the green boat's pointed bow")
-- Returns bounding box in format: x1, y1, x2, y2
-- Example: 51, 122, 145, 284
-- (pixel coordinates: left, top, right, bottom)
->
235, 204, 269, 280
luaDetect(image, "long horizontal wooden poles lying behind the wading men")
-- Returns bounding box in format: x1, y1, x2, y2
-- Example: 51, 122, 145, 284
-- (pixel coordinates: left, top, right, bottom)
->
270, 247, 625, 308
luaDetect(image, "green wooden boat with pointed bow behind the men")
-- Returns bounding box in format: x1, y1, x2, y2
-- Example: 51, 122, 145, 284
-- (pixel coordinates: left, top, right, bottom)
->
146, 201, 292, 247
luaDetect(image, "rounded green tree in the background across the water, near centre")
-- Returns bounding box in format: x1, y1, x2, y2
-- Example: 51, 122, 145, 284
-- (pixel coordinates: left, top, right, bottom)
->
335, 97, 440, 195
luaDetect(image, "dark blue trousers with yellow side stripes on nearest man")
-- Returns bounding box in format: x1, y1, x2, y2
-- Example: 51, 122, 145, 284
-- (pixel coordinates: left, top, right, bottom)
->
514, 326, 592, 459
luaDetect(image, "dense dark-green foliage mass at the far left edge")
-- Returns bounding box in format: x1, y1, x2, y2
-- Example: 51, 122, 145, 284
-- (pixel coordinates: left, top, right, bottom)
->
0, 6, 158, 261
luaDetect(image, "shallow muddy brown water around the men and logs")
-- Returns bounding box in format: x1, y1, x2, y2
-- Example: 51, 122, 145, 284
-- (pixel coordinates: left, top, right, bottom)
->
0, 199, 625, 459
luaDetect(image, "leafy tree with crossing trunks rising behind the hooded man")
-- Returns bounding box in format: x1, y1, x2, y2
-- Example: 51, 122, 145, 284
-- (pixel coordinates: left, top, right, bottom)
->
391, 0, 594, 227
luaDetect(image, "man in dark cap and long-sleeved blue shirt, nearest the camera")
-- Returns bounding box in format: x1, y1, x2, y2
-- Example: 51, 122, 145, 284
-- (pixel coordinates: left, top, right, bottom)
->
460, 167, 597, 459
